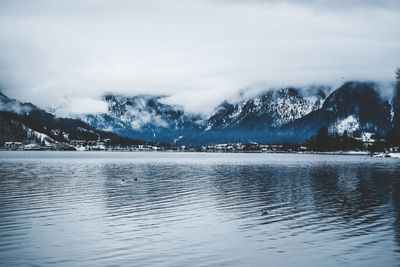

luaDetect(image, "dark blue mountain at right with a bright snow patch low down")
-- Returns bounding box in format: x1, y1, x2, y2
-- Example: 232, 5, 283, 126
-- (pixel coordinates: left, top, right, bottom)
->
282, 82, 392, 141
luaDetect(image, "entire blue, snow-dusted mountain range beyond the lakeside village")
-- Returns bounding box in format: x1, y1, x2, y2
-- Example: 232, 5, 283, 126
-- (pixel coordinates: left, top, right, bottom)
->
0, 81, 398, 145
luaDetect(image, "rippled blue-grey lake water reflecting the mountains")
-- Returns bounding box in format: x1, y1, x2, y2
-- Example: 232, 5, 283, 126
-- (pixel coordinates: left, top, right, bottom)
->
0, 151, 400, 267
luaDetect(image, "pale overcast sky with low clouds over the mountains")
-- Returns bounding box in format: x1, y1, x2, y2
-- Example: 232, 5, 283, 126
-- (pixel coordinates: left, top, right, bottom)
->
0, 0, 400, 112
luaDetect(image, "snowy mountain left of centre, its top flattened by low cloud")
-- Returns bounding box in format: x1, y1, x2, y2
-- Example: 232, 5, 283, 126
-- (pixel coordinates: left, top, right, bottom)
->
77, 95, 203, 142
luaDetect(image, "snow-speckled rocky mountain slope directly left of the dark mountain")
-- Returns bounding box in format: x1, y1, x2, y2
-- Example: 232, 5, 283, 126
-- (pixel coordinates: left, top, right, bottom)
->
206, 87, 329, 130
